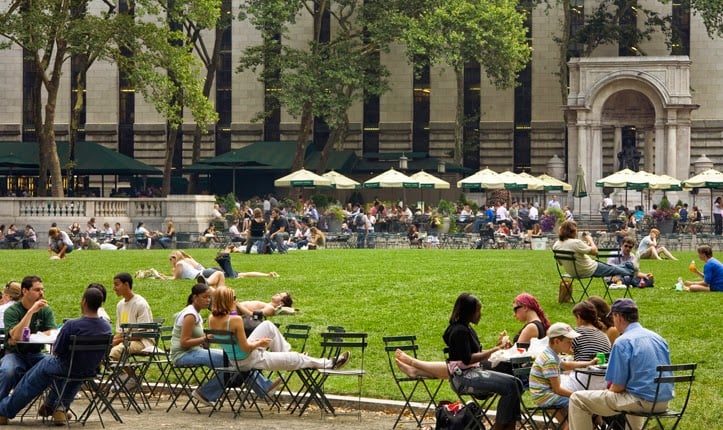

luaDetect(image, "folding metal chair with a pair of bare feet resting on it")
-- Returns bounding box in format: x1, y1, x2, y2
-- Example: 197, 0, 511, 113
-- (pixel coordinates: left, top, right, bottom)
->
382, 335, 444, 429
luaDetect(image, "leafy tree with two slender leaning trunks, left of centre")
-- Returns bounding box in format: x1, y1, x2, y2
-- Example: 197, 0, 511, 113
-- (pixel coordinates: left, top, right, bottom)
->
239, 0, 392, 170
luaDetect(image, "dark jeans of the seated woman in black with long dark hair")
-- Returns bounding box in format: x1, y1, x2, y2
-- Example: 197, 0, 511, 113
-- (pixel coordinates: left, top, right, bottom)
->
451, 367, 522, 424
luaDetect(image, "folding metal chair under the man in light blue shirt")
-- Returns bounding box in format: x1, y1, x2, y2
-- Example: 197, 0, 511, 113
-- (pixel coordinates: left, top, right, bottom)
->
623, 363, 698, 430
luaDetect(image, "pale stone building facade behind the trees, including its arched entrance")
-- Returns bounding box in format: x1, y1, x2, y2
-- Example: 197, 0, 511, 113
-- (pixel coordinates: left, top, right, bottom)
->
0, 0, 723, 210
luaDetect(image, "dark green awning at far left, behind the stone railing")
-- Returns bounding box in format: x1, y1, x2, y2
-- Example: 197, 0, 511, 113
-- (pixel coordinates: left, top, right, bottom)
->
0, 142, 163, 175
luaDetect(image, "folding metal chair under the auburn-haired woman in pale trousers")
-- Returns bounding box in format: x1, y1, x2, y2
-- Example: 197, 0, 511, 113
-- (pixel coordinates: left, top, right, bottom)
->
205, 329, 264, 418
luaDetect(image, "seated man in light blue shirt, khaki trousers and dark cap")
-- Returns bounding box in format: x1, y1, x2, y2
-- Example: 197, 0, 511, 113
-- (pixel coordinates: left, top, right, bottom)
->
569, 299, 673, 430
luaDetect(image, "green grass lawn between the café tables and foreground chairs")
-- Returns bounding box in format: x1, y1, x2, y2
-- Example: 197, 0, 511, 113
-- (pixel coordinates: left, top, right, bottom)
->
0, 249, 723, 429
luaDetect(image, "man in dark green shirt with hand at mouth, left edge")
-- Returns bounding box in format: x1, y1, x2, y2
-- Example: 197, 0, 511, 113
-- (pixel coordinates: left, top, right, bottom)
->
0, 275, 55, 399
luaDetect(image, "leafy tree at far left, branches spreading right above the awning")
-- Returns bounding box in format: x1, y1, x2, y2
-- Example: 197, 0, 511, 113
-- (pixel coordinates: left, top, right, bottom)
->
0, 0, 215, 197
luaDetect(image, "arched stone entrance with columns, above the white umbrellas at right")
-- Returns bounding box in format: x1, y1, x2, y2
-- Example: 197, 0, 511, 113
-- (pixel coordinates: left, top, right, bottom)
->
564, 56, 698, 213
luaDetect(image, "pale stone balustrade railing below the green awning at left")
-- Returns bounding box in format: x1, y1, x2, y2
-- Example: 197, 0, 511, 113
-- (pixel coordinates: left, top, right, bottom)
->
0, 195, 215, 243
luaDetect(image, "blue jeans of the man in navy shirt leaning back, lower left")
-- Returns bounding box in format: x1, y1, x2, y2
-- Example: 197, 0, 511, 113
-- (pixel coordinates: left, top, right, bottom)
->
0, 354, 81, 418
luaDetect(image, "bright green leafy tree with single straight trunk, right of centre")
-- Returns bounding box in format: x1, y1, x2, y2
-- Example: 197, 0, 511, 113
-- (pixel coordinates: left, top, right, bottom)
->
402, 0, 530, 164
